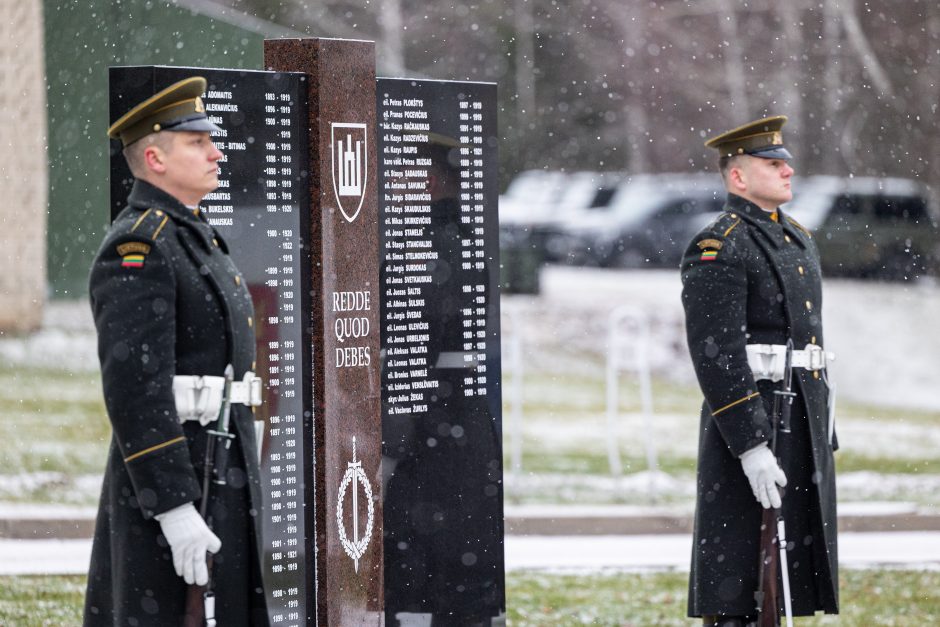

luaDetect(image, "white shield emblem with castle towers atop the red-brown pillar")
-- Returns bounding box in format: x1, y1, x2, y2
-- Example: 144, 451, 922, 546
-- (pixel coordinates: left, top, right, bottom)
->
330, 122, 369, 222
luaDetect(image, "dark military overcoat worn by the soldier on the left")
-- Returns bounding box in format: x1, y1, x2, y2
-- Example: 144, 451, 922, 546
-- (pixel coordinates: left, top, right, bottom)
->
85, 181, 267, 626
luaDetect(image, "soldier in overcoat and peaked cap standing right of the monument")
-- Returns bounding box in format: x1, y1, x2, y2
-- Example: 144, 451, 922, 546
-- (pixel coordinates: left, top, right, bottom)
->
681, 116, 839, 627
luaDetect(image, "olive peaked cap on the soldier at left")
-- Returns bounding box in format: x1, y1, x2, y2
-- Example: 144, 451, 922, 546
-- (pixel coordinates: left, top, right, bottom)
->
108, 76, 222, 147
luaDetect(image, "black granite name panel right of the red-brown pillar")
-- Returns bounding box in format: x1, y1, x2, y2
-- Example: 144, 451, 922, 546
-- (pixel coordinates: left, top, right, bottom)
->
376, 78, 505, 625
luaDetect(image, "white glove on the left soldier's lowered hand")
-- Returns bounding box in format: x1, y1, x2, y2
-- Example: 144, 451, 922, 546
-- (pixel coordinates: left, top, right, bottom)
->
154, 503, 222, 586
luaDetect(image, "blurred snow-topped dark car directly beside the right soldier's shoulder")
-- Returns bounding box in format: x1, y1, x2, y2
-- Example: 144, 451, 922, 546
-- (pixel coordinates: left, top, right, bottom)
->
549, 174, 726, 268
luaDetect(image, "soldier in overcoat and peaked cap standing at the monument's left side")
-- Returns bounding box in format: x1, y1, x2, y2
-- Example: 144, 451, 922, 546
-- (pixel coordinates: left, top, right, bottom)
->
85, 77, 268, 626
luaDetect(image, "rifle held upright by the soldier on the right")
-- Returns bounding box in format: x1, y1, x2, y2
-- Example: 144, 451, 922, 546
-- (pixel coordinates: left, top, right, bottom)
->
754, 340, 796, 627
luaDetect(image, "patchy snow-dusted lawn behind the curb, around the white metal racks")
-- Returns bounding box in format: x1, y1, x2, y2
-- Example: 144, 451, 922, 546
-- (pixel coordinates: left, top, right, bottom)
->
0, 357, 940, 506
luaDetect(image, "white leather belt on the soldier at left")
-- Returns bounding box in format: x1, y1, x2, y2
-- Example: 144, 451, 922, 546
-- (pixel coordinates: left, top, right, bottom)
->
173, 371, 261, 426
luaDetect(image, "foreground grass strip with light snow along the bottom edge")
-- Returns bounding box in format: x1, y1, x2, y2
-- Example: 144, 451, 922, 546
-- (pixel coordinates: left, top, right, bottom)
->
7, 570, 940, 627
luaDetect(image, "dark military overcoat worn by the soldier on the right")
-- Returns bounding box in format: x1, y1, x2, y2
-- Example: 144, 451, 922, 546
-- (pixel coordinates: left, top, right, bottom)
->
682, 194, 838, 616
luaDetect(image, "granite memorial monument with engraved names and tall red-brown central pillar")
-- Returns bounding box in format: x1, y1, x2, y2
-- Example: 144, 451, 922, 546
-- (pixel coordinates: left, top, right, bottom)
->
110, 39, 505, 625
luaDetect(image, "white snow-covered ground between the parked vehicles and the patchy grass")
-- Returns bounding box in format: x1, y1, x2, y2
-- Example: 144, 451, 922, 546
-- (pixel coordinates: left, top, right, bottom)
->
510, 266, 940, 409
